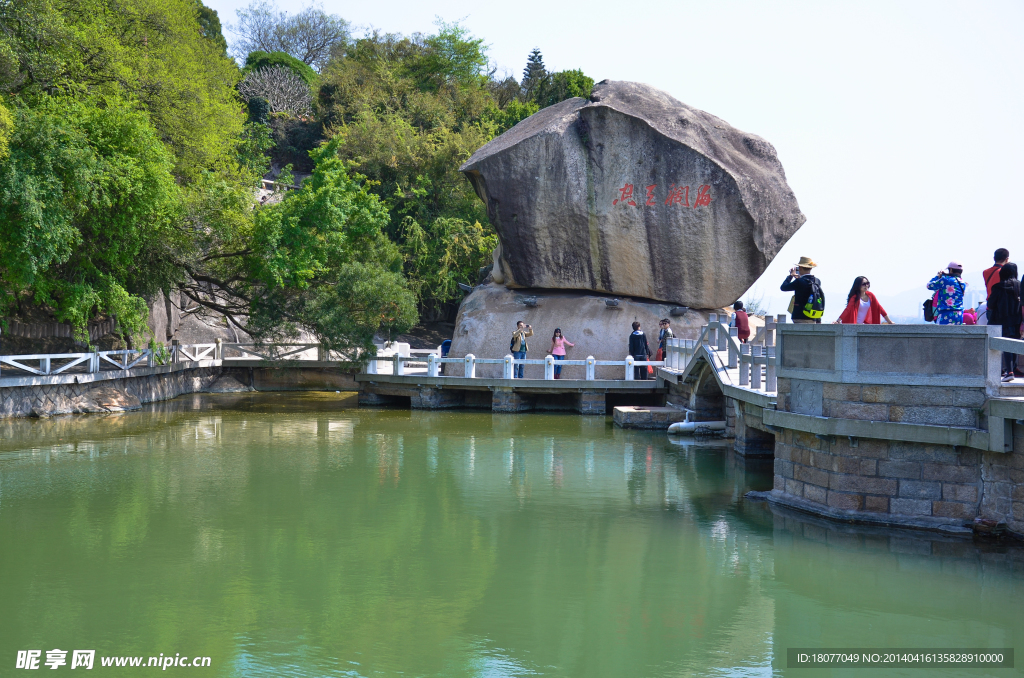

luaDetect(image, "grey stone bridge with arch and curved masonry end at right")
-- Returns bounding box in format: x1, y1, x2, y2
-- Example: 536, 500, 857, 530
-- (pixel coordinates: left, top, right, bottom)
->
655, 324, 1024, 536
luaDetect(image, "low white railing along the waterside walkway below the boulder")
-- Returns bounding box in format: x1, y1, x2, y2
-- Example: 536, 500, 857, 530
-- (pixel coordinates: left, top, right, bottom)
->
367, 352, 666, 381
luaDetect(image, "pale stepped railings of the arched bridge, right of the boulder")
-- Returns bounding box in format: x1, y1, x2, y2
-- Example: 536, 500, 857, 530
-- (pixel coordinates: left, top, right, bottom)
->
665, 313, 786, 393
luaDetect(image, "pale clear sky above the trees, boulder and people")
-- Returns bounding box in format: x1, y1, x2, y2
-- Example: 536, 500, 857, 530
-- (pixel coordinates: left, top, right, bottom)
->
206, 0, 1024, 321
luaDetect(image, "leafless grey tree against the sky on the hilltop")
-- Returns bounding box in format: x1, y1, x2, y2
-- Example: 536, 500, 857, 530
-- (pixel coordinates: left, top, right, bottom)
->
231, 0, 349, 71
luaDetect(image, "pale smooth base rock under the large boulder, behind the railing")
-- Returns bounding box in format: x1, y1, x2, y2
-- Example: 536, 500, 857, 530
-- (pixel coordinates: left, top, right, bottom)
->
445, 284, 707, 379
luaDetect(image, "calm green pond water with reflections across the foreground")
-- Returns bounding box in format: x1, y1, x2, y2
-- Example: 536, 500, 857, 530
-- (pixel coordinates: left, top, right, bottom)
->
0, 393, 1024, 677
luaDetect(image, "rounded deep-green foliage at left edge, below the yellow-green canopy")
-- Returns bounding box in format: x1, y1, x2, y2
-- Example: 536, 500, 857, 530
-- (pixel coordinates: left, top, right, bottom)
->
0, 97, 178, 336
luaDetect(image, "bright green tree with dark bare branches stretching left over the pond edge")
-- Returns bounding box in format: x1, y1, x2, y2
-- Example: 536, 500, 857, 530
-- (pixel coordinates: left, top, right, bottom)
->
180, 140, 416, 353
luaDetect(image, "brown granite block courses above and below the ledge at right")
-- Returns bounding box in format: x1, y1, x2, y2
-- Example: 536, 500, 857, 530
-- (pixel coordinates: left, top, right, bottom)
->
772, 379, 1024, 535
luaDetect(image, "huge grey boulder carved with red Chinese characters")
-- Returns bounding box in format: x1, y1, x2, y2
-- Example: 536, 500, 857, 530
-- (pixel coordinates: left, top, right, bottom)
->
462, 81, 805, 308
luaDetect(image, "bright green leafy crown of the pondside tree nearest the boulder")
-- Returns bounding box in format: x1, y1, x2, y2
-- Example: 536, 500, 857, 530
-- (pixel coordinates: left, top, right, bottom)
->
244, 141, 417, 350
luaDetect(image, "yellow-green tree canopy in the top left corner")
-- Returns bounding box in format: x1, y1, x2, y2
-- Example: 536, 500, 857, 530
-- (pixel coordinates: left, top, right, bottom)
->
0, 0, 245, 181
